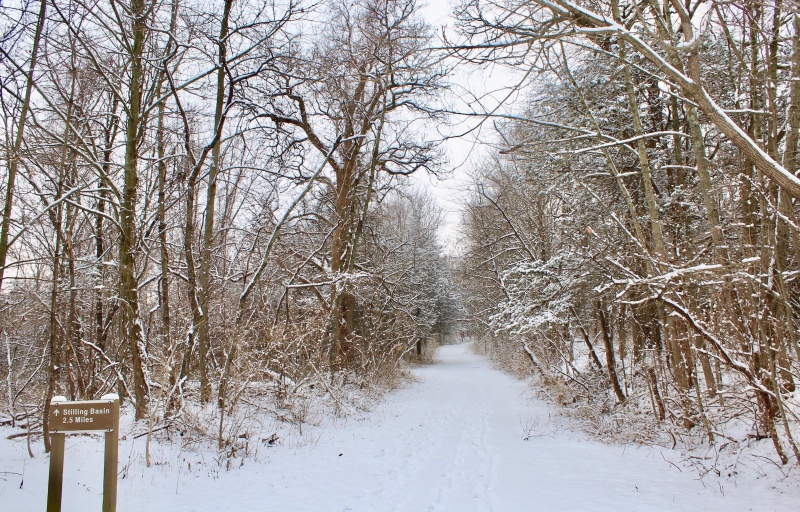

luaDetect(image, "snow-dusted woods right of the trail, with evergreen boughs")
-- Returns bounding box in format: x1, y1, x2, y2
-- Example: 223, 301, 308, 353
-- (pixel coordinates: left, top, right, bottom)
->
460, 0, 800, 464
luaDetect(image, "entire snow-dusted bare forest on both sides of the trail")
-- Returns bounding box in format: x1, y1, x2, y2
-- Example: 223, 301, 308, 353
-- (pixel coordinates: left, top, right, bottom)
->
0, 0, 800, 474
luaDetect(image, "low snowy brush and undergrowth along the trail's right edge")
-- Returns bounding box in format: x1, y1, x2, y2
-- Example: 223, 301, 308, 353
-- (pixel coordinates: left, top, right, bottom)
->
473, 336, 800, 484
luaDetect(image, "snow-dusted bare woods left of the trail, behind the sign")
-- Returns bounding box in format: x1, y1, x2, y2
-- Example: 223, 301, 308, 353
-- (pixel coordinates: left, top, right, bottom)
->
0, 0, 456, 456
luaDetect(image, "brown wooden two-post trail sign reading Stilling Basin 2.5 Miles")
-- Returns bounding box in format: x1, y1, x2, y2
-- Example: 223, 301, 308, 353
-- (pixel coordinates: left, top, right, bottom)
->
47, 394, 119, 512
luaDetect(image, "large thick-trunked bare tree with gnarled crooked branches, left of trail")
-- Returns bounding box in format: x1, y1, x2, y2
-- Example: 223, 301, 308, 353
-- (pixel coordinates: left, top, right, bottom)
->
265, 0, 440, 366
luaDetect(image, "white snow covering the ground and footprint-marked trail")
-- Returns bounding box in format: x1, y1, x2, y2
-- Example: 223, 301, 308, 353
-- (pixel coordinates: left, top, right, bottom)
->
0, 345, 800, 512
